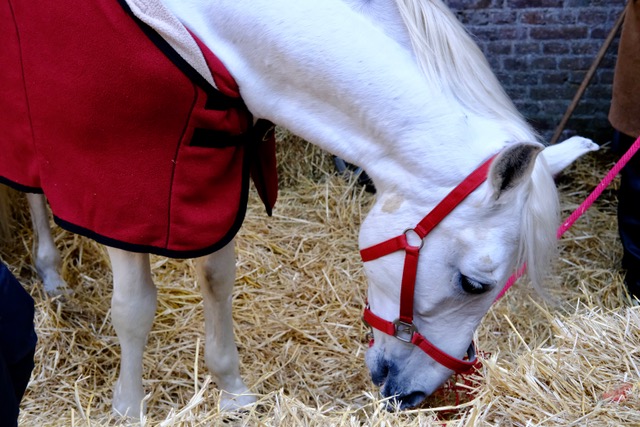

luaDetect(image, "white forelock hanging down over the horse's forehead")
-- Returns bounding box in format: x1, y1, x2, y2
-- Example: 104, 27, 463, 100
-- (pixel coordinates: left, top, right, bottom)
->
517, 156, 560, 295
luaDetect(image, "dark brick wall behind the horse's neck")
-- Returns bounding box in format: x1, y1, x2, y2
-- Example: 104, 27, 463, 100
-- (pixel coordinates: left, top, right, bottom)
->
445, 0, 625, 143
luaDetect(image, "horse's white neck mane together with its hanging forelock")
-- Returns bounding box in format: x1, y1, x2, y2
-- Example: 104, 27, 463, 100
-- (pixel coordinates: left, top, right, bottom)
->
396, 0, 559, 295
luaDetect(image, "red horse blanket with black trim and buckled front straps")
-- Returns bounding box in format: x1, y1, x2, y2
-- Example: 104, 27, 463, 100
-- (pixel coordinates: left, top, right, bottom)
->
0, 0, 277, 258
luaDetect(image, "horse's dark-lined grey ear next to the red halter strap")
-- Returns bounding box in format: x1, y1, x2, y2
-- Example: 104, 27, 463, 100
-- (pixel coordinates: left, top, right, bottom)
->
489, 143, 543, 200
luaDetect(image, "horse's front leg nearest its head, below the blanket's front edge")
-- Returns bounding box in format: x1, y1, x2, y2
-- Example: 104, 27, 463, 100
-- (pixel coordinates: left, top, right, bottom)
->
196, 241, 256, 410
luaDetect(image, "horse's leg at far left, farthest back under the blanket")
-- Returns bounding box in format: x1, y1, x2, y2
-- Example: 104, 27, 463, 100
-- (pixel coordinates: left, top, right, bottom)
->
27, 193, 70, 296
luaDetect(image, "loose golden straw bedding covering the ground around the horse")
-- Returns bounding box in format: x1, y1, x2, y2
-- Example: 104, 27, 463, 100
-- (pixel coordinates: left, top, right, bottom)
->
0, 132, 640, 426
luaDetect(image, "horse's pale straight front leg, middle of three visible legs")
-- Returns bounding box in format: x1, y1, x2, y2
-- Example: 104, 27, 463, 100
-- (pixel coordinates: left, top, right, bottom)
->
107, 248, 157, 418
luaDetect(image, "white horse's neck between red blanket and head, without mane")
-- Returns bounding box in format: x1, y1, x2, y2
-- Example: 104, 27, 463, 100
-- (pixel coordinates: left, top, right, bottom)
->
165, 0, 520, 199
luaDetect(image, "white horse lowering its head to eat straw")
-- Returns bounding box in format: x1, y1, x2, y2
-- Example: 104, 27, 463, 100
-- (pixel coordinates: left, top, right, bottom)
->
1, 0, 597, 415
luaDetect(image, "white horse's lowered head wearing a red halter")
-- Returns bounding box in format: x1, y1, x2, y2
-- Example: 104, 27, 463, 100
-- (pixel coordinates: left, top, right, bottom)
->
360, 137, 597, 408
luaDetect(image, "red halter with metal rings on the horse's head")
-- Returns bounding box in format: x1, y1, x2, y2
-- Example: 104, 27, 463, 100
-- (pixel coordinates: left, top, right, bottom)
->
360, 156, 495, 374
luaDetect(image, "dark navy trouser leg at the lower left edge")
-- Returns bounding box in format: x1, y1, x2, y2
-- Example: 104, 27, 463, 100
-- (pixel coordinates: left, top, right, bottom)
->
0, 262, 37, 427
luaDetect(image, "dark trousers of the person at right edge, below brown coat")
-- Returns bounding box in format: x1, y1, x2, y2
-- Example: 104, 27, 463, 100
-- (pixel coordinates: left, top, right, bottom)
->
613, 132, 640, 298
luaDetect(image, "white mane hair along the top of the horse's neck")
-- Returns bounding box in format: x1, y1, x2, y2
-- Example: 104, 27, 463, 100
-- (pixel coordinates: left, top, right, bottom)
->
396, 0, 537, 141
